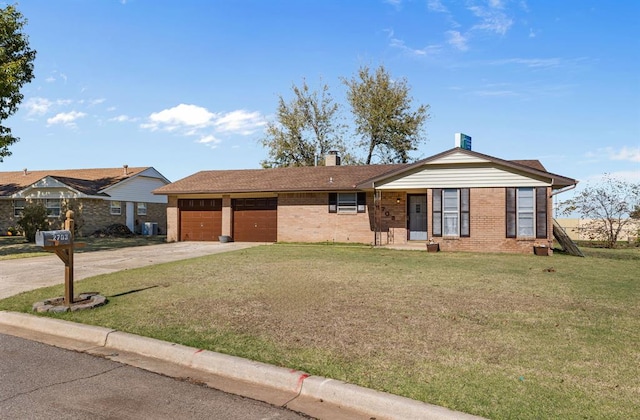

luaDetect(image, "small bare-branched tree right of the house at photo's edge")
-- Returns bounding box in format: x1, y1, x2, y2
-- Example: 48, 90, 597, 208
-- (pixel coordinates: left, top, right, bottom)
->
560, 175, 640, 248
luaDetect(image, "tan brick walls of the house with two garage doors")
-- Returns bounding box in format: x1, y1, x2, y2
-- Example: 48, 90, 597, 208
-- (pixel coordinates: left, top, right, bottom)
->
161, 188, 553, 253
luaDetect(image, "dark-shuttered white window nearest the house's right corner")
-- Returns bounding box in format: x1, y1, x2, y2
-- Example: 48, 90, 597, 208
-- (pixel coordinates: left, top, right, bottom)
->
506, 187, 547, 238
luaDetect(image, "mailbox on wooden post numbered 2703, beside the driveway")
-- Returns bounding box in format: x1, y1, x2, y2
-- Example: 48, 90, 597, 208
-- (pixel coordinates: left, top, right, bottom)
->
36, 210, 84, 307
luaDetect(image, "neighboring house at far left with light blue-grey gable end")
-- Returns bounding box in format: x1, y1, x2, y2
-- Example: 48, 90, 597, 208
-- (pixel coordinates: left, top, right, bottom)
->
0, 165, 169, 235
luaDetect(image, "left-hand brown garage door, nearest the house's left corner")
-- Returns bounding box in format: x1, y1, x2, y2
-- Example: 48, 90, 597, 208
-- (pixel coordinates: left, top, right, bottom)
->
178, 198, 222, 241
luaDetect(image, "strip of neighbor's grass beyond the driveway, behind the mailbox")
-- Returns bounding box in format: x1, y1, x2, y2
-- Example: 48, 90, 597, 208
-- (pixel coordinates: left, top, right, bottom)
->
0, 236, 166, 261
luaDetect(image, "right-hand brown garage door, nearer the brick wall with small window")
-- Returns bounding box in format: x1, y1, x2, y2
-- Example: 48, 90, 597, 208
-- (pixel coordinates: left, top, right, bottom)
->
233, 197, 278, 242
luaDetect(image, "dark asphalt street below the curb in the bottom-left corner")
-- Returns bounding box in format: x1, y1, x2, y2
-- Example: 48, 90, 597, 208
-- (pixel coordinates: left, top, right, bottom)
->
0, 334, 308, 420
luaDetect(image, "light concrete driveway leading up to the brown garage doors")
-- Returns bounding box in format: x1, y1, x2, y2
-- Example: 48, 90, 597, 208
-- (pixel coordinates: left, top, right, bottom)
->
0, 242, 262, 299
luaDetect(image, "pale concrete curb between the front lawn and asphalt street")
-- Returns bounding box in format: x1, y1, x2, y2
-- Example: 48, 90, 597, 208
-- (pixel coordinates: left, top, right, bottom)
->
0, 311, 481, 420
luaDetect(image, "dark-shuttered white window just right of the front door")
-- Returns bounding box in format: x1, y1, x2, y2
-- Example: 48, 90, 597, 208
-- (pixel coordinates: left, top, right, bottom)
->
431, 188, 471, 237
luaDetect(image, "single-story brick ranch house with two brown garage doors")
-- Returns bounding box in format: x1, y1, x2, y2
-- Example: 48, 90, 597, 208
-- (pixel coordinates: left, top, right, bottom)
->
154, 147, 577, 253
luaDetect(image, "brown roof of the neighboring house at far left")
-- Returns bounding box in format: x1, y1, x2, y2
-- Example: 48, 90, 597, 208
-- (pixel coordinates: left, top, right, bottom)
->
0, 166, 169, 198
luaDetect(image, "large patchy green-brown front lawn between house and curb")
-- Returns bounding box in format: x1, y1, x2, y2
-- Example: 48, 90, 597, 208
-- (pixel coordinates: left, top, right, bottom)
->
0, 245, 640, 419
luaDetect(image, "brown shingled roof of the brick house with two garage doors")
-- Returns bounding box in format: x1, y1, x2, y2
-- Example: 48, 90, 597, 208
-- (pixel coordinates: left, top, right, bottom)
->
153, 148, 577, 195
